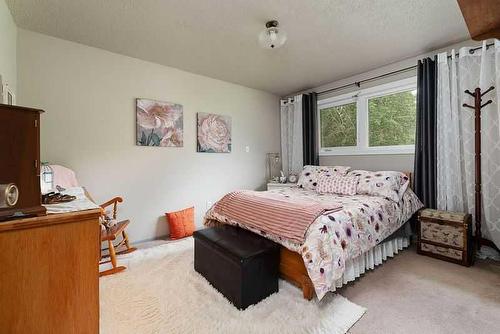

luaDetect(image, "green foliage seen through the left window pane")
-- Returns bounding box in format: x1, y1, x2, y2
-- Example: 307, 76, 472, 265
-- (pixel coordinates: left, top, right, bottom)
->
320, 102, 357, 147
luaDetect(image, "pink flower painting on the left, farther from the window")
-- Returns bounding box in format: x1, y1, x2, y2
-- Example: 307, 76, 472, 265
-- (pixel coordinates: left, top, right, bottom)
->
136, 99, 184, 147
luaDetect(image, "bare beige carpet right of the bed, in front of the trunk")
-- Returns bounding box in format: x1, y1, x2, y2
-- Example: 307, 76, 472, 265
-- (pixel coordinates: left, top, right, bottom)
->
338, 248, 500, 334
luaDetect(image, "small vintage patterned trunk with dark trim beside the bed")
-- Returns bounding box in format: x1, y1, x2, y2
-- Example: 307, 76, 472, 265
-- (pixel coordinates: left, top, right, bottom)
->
417, 209, 474, 266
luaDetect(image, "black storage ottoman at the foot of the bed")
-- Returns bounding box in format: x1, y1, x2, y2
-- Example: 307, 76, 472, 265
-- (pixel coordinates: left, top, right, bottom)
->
193, 225, 280, 310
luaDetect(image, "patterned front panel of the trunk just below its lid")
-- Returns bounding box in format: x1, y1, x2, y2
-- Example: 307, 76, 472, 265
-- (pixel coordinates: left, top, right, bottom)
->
420, 220, 464, 248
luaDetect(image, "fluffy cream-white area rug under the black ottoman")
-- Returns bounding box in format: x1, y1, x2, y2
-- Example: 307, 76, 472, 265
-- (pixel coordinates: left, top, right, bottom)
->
100, 238, 366, 334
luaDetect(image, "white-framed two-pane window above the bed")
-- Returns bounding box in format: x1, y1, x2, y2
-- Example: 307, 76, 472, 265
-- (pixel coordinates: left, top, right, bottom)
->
318, 78, 416, 155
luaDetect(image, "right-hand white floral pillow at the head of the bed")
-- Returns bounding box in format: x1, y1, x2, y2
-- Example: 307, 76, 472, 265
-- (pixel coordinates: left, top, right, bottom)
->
347, 170, 410, 202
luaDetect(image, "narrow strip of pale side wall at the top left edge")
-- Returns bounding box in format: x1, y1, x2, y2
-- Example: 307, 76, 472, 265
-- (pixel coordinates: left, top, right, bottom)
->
0, 0, 17, 94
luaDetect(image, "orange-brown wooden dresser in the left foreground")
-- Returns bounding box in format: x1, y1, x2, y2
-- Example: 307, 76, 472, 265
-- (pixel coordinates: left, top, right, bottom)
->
0, 209, 100, 334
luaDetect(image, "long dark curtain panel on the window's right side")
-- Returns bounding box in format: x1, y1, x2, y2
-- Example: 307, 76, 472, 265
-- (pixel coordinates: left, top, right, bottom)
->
414, 57, 437, 208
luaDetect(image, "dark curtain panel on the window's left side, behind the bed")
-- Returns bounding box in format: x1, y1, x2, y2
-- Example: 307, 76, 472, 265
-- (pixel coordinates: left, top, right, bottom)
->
302, 92, 319, 165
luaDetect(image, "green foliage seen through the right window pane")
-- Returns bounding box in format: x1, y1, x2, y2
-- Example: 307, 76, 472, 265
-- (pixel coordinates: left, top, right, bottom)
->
368, 91, 417, 146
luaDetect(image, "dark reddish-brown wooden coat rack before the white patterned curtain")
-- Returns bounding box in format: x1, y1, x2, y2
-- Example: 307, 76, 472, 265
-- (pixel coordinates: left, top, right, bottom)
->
462, 86, 495, 248
